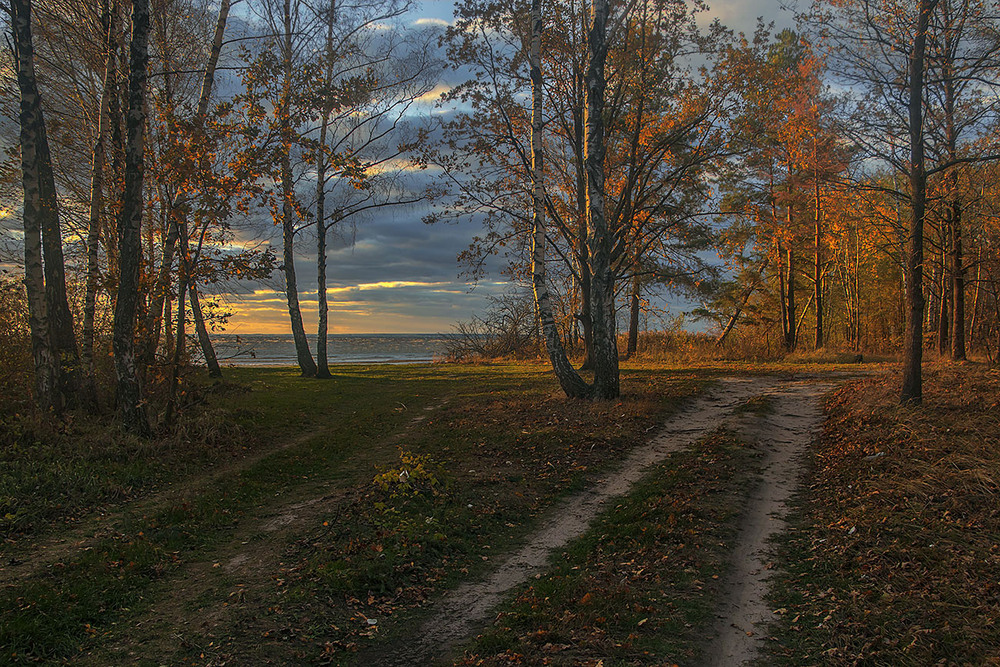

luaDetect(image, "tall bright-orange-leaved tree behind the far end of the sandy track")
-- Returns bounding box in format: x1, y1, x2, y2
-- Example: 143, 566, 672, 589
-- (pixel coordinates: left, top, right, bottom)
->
721, 28, 850, 351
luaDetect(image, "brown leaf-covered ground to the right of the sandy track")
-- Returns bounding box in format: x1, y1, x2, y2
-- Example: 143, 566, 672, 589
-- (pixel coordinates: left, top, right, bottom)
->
761, 365, 1000, 666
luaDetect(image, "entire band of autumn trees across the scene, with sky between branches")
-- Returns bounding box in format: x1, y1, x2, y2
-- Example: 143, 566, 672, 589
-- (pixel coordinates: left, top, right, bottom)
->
0, 0, 1000, 434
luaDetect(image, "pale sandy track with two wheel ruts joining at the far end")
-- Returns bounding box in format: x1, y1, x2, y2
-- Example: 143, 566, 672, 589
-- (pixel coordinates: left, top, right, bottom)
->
370, 378, 829, 665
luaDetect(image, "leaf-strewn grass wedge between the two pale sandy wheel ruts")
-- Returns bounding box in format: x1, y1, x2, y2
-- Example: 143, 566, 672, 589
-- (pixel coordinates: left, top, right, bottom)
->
459, 431, 758, 667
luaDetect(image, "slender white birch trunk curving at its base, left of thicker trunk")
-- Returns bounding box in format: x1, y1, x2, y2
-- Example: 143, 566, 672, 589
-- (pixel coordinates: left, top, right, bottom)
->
528, 0, 590, 398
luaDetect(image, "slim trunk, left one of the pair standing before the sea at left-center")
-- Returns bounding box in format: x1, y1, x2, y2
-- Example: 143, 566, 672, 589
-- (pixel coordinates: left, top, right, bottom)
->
278, 0, 316, 377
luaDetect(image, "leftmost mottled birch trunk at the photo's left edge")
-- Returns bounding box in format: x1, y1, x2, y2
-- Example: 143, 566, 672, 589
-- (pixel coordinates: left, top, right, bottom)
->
11, 0, 63, 411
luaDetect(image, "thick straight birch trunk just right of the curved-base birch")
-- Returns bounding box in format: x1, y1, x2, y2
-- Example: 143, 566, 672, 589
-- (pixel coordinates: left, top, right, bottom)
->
585, 0, 620, 399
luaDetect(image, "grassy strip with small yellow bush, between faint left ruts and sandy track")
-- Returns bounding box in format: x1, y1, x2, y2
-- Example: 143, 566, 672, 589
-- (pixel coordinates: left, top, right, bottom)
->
146, 365, 705, 664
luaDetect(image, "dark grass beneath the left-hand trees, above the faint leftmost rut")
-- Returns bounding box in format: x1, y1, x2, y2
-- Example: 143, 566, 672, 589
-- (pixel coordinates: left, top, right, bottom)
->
0, 378, 255, 544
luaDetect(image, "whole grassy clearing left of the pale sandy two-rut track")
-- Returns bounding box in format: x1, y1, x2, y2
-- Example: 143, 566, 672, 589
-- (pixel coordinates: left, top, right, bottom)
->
0, 364, 709, 664
